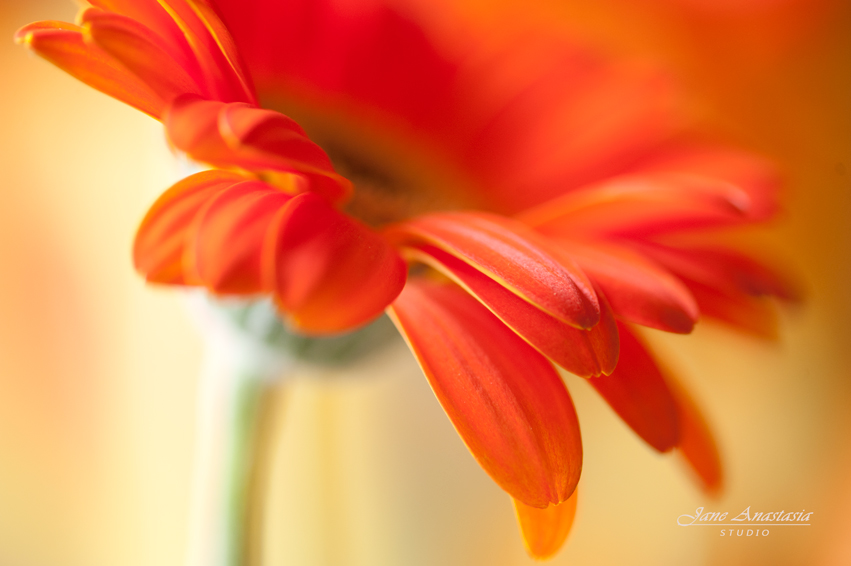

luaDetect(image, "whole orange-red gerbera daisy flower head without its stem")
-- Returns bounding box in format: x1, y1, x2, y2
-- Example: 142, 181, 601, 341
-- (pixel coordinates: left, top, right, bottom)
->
17, 0, 793, 557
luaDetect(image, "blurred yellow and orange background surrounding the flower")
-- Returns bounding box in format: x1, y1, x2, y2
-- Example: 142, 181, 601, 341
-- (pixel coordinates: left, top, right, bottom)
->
0, 0, 851, 566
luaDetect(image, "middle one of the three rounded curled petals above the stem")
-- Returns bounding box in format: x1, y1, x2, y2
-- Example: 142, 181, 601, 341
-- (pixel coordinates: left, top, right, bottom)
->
183, 181, 292, 295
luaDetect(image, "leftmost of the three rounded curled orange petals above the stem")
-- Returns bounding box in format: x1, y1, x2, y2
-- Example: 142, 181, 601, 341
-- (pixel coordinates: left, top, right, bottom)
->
133, 171, 245, 285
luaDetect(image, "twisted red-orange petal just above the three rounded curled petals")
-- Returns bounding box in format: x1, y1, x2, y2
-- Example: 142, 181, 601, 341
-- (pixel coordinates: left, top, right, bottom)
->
163, 96, 351, 202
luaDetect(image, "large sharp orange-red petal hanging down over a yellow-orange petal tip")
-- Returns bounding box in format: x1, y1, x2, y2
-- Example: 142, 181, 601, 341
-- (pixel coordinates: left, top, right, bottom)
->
388, 279, 582, 509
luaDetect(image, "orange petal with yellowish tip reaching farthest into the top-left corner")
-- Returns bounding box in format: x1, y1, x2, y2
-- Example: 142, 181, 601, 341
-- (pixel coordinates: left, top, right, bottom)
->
15, 22, 165, 119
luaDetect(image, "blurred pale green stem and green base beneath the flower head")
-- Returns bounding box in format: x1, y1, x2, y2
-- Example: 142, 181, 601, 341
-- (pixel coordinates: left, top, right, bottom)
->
188, 296, 397, 566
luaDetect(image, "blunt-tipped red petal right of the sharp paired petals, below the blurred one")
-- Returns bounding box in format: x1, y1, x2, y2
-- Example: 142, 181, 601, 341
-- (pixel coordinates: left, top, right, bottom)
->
558, 240, 700, 334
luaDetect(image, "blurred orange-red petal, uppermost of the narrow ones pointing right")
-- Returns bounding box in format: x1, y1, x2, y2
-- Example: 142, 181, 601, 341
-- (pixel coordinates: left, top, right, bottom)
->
520, 174, 751, 238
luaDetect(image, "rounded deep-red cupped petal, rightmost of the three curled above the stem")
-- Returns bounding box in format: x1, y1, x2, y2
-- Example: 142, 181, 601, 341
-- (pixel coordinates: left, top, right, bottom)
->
263, 193, 406, 334
